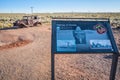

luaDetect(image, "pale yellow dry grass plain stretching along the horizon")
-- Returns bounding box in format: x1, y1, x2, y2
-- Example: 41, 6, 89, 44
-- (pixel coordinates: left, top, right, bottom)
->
0, 12, 120, 23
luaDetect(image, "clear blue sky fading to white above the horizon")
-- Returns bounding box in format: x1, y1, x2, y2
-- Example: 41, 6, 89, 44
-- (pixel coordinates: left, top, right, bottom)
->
0, 0, 120, 13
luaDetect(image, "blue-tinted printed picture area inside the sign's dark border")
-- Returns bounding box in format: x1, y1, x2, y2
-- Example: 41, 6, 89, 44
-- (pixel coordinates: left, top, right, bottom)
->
56, 23, 113, 52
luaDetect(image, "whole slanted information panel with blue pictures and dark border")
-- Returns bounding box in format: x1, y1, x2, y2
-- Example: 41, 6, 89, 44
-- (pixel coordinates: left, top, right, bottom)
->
52, 19, 115, 53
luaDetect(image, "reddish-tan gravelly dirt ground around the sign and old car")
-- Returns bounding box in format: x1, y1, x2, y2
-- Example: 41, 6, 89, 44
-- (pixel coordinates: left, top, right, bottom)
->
0, 25, 120, 80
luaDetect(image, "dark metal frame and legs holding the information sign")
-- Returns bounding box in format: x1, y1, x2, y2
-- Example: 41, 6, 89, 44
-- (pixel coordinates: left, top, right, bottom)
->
51, 18, 119, 80
